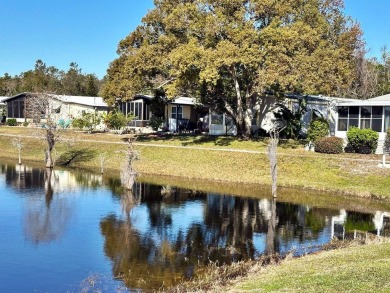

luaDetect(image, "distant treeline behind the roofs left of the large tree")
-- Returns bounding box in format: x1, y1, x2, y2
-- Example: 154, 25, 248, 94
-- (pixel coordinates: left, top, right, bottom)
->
0, 60, 103, 97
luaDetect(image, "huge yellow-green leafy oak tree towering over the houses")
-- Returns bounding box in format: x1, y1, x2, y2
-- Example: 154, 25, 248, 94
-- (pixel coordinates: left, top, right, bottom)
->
102, 0, 362, 136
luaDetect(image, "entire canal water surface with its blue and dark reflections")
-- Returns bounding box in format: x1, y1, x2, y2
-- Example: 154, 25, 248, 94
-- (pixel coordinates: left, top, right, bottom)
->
0, 163, 390, 292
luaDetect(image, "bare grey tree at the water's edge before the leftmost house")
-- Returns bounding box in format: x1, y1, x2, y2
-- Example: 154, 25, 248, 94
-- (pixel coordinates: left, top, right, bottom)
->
26, 93, 61, 168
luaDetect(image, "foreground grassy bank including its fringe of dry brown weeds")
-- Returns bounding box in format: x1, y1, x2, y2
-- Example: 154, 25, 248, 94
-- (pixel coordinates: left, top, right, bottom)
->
168, 239, 390, 292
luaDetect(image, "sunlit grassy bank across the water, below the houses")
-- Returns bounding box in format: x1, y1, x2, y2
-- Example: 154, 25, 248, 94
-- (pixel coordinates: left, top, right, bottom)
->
0, 127, 390, 198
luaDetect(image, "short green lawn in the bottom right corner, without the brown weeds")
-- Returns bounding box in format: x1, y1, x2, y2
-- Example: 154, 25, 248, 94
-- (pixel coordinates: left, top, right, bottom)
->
230, 243, 390, 292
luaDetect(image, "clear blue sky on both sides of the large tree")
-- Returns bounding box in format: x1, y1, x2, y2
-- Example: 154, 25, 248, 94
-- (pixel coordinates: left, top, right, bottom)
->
0, 0, 390, 78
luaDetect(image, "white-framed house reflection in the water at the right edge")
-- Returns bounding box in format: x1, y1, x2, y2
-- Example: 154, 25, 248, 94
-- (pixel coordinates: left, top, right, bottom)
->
331, 210, 390, 239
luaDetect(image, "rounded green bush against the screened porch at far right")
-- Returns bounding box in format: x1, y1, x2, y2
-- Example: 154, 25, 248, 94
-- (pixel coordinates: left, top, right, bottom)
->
347, 126, 379, 154
